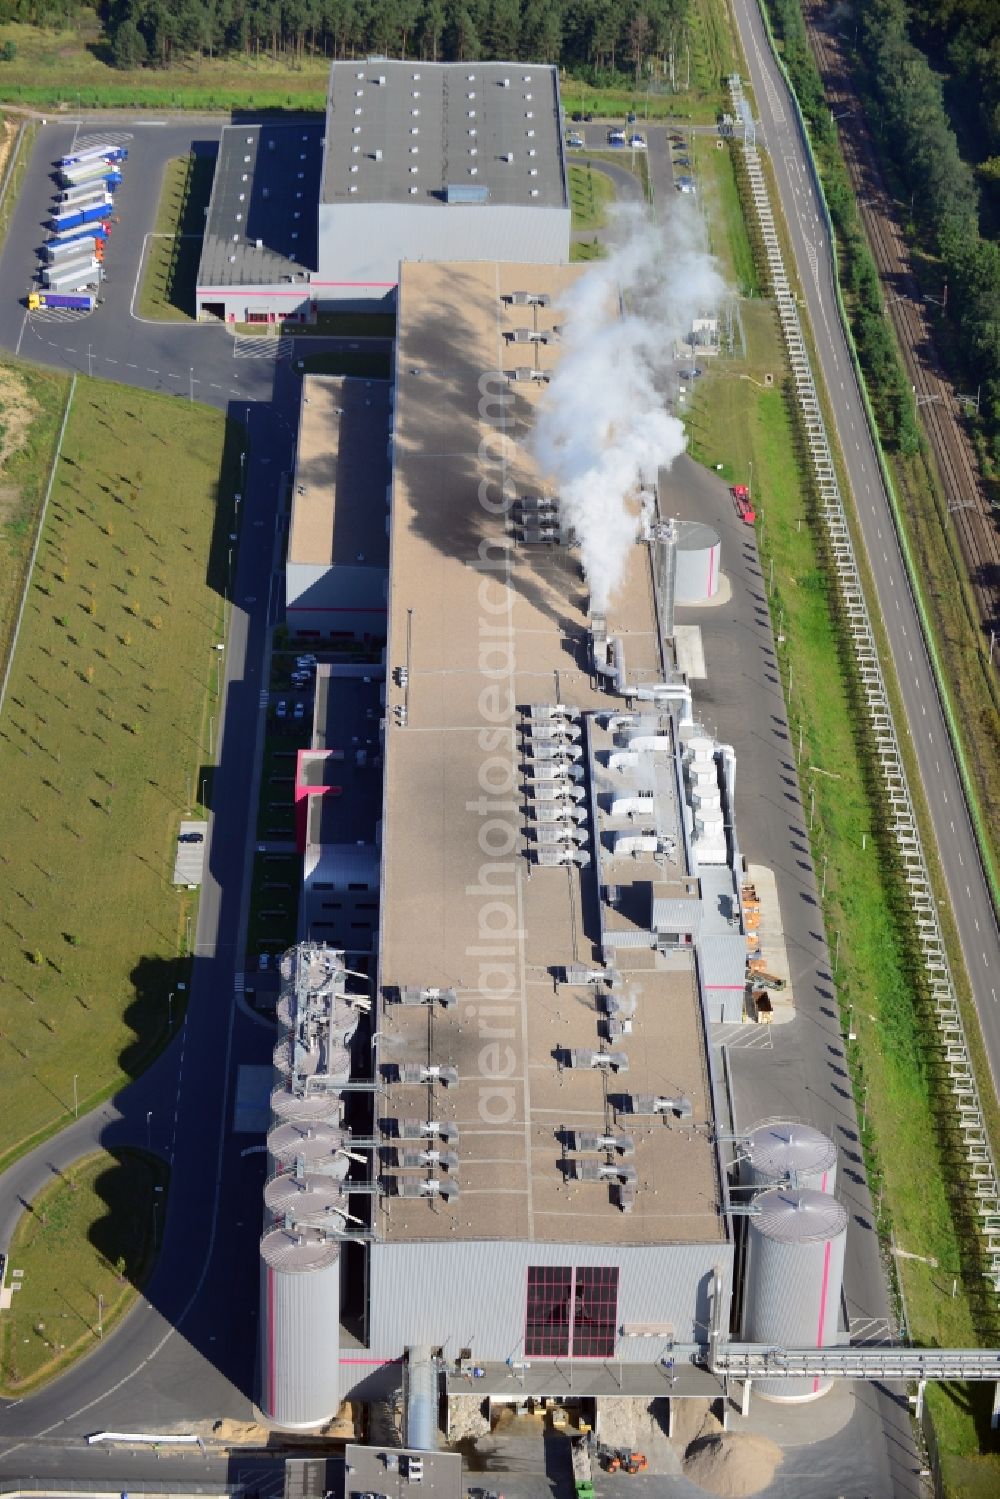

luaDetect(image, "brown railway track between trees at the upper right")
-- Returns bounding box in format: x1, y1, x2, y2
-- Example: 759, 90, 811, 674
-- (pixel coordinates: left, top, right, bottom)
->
804, 0, 1000, 636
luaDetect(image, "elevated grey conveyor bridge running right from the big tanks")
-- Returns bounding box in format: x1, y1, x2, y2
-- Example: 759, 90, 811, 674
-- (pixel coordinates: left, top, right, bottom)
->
712, 1343, 1000, 1384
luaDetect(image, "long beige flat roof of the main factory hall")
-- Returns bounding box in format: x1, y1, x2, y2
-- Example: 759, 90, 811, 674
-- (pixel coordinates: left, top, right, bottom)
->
376, 262, 724, 1244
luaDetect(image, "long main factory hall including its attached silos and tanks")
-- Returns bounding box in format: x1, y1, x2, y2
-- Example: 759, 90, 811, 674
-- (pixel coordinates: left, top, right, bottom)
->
259, 260, 847, 1448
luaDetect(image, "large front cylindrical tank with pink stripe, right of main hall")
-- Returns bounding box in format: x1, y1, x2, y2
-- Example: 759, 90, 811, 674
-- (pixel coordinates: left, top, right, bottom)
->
744, 1187, 847, 1402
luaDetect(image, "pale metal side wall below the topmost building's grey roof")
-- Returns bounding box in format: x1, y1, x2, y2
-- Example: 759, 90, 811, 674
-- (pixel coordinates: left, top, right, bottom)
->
319, 202, 570, 286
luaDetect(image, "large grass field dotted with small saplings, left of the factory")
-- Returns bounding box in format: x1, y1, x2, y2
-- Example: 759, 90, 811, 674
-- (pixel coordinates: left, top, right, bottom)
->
0, 379, 240, 1162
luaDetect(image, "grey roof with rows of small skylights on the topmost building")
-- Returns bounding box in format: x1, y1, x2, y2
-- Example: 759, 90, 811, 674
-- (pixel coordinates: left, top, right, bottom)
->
321, 60, 568, 208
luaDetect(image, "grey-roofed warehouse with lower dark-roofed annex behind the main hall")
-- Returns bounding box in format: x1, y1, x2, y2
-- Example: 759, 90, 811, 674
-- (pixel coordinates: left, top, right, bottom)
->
196, 58, 570, 324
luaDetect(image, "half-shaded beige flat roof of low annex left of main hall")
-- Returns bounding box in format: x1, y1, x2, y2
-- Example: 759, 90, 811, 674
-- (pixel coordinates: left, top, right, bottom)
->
288, 375, 390, 567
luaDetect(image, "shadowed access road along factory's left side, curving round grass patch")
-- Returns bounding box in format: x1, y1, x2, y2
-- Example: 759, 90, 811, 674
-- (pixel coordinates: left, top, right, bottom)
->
0, 340, 308, 1480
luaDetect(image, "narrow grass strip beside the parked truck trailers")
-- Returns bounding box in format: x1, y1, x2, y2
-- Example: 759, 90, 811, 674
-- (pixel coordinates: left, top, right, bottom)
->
139, 151, 214, 322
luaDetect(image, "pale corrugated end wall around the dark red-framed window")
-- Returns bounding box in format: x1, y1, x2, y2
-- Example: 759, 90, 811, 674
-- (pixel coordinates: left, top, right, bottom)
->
370, 1240, 733, 1364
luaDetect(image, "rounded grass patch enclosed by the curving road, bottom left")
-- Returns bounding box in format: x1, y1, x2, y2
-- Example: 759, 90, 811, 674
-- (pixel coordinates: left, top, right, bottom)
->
0, 1150, 169, 1399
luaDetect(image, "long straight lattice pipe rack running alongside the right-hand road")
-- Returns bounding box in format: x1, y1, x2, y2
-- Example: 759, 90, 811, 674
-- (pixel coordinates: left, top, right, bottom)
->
729, 75, 1000, 1291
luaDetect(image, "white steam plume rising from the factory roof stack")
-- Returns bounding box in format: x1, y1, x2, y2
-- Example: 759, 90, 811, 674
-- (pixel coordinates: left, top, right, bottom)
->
532, 202, 726, 613
